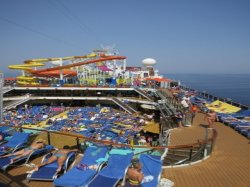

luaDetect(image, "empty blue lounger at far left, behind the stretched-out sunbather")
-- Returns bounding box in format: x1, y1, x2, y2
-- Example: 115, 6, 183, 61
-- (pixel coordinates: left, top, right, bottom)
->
0, 132, 30, 156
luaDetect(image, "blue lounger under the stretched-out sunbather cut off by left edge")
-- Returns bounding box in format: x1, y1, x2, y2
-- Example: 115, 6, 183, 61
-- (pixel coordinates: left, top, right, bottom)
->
0, 145, 54, 172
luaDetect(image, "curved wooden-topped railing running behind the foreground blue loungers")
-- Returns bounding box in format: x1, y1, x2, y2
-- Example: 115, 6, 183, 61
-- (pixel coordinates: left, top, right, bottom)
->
0, 125, 217, 166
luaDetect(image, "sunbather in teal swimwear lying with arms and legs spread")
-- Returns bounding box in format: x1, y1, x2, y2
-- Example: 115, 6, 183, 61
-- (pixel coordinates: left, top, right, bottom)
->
28, 146, 78, 173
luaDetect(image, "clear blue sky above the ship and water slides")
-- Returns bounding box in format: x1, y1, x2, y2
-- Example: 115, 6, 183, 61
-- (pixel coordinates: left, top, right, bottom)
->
0, 0, 250, 74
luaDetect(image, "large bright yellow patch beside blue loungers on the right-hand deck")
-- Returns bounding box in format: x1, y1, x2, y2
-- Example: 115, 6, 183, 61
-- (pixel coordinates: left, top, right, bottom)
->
206, 100, 241, 113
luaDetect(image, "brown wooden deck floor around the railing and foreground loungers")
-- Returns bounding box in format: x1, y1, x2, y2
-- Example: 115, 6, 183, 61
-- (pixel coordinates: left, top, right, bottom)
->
0, 114, 250, 187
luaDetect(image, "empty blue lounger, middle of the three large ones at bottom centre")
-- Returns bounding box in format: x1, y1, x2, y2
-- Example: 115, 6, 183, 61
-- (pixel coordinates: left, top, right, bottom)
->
87, 152, 133, 187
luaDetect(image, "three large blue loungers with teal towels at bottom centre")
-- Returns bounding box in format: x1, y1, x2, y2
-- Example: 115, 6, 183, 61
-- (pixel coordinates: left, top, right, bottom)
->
54, 146, 162, 187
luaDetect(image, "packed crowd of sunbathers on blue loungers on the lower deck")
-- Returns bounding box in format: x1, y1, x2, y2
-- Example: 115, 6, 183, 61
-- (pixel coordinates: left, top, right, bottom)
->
1, 104, 159, 145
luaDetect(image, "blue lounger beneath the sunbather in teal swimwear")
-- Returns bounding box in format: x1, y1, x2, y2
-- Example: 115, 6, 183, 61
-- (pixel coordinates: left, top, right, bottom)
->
27, 149, 76, 181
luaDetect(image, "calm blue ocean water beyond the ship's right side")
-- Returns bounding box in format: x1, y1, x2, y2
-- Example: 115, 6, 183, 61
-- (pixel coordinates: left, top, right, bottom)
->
164, 74, 250, 106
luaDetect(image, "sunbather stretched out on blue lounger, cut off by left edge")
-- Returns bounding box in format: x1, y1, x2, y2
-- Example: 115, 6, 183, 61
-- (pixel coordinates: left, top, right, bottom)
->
0, 139, 45, 164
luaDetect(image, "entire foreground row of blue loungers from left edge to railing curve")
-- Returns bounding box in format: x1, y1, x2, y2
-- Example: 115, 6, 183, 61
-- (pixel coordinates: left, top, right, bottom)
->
0, 132, 162, 187
